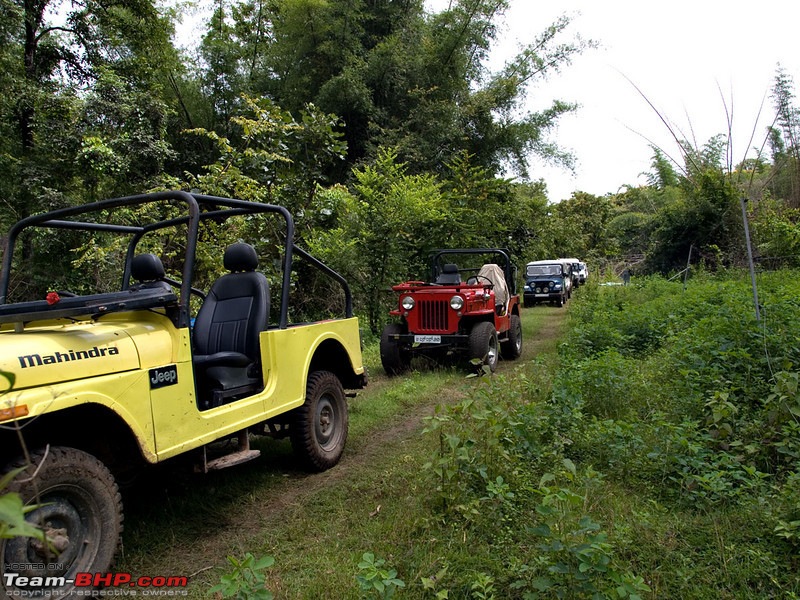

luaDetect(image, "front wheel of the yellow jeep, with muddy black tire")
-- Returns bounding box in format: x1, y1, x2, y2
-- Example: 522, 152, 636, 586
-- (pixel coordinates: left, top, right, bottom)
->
0, 446, 122, 596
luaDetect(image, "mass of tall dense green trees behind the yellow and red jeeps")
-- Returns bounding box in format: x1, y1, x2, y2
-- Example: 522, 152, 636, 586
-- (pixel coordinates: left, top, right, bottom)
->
0, 0, 592, 331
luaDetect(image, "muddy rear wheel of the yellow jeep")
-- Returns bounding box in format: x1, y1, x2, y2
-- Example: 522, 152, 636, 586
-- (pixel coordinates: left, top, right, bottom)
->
289, 371, 349, 471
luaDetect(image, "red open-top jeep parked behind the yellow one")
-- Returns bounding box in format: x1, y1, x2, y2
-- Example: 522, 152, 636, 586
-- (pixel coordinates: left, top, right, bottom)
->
381, 248, 522, 375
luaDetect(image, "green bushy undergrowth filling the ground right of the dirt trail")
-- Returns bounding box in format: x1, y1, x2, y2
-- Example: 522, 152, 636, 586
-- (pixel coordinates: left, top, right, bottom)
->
418, 272, 800, 599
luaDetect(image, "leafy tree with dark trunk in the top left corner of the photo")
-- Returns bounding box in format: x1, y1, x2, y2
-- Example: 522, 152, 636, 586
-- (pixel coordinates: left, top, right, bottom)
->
0, 0, 174, 219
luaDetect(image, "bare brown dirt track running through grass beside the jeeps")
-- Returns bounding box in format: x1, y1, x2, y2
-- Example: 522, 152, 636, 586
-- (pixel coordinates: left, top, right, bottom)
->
122, 308, 566, 575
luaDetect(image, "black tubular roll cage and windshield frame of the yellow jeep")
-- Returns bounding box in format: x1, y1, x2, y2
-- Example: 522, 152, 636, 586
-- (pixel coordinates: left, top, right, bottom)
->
0, 190, 353, 329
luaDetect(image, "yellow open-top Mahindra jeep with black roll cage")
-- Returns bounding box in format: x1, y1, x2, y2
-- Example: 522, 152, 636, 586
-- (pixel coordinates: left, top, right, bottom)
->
0, 191, 367, 595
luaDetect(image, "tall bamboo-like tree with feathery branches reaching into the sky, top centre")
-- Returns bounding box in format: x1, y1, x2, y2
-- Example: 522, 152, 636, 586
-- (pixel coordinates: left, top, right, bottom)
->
206, 0, 591, 181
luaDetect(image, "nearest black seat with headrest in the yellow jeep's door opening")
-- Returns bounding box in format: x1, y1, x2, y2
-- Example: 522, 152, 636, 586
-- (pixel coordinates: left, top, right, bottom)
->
192, 242, 269, 409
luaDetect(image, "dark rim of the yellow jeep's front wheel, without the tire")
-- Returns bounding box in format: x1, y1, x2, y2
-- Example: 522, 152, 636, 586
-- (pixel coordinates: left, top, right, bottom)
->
2, 485, 102, 577
